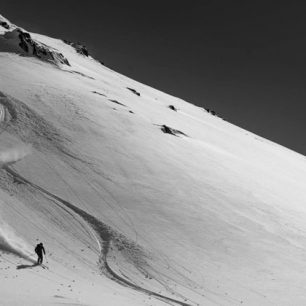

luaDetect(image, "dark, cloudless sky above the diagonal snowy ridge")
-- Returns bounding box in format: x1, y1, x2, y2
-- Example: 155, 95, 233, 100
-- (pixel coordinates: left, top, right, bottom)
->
0, 0, 306, 155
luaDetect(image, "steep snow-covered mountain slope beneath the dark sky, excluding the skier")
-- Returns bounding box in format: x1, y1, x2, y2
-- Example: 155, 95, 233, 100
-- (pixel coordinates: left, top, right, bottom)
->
0, 16, 306, 306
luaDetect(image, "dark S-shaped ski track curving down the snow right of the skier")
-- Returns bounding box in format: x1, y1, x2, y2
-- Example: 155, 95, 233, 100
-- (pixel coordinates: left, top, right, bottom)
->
4, 166, 192, 306
